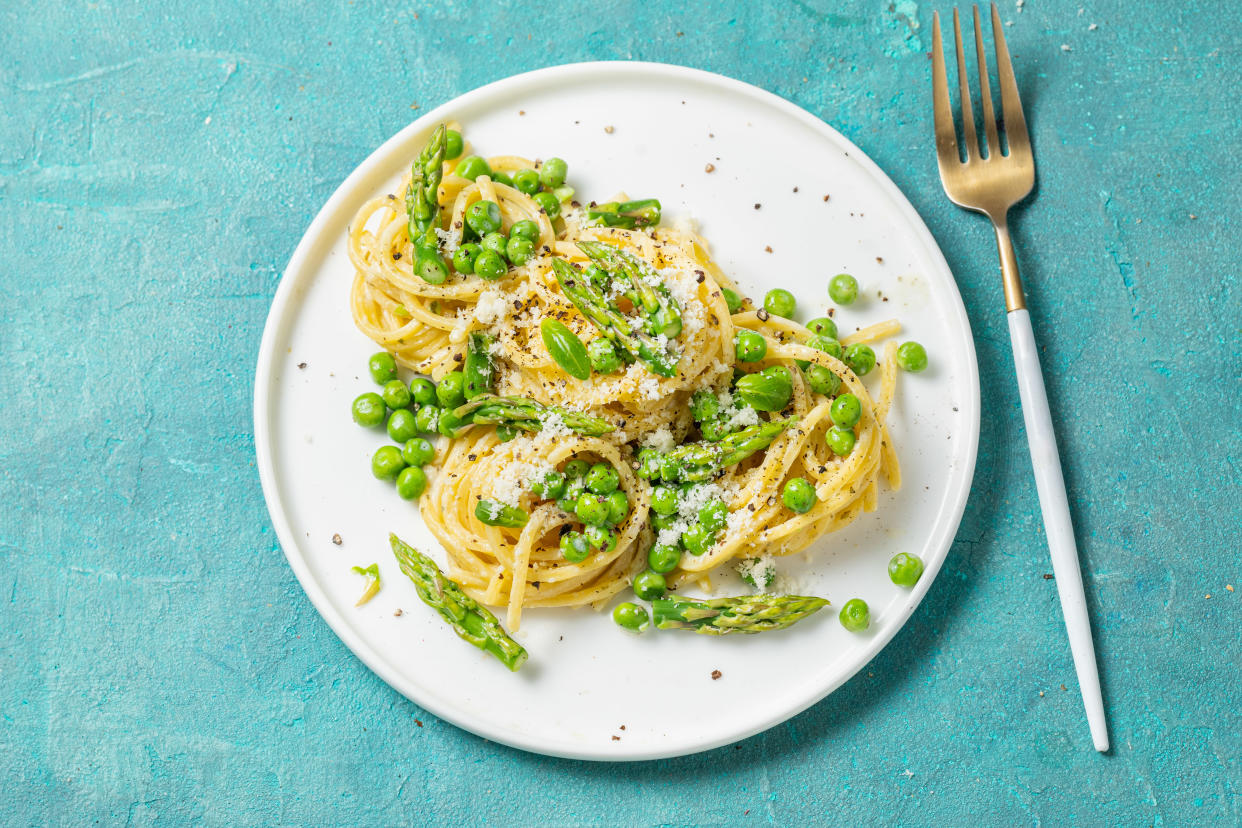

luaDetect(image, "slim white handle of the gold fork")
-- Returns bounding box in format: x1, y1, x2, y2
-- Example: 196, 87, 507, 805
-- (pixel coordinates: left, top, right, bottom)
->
1009, 308, 1108, 752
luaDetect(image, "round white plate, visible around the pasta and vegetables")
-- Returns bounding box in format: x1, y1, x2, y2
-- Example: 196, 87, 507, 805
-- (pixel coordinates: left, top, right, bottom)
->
255, 63, 979, 760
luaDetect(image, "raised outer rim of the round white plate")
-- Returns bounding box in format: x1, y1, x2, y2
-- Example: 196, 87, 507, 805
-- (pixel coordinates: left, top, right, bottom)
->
253, 61, 981, 762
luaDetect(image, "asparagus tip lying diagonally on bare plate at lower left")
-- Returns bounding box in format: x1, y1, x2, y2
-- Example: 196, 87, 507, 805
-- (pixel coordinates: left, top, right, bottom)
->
389, 535, 527, 672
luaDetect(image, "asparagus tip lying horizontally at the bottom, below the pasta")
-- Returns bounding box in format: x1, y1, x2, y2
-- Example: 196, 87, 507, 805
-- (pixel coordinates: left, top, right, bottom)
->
651, 595, 828, 636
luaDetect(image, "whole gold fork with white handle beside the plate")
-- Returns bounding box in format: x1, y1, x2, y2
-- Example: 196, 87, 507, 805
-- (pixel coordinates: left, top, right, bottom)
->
932, 2, 1108, 751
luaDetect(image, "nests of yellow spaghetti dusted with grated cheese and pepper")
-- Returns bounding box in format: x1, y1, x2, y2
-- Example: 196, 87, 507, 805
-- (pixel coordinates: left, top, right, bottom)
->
349, 127, 899, 627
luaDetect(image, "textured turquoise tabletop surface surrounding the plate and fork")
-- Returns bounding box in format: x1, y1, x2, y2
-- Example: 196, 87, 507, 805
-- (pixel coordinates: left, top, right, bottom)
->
0, 0, 1242, 826
